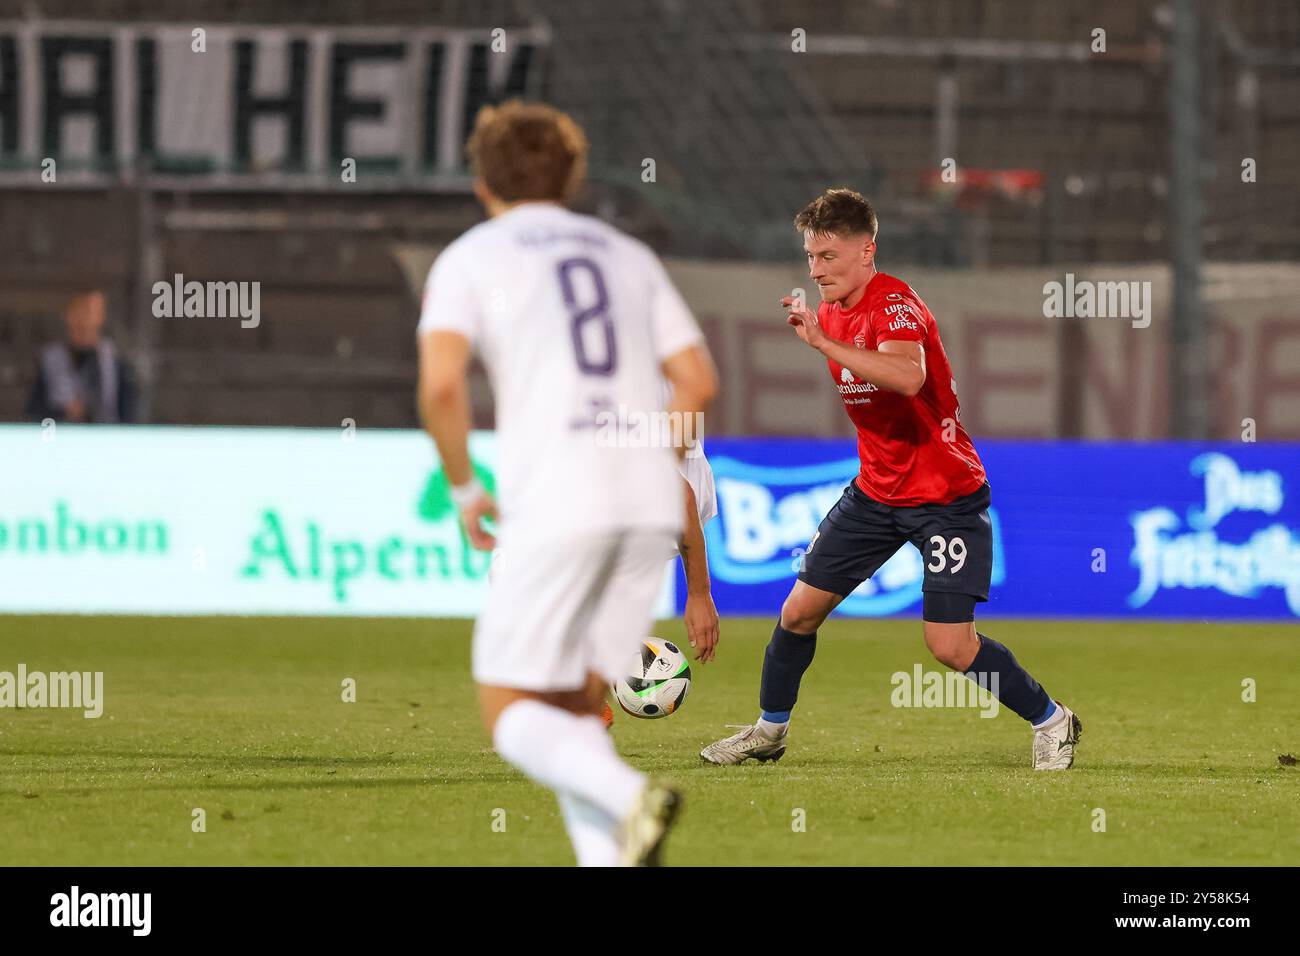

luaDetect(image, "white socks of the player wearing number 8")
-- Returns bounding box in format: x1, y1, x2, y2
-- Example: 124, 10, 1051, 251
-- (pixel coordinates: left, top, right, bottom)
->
493, 700, 646, 866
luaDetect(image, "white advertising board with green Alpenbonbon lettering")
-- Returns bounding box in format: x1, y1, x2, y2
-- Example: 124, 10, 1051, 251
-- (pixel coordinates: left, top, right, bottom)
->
0, 425, 673, 618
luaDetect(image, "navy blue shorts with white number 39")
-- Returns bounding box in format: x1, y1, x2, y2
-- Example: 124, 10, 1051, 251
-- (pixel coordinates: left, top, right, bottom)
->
800, 481, 993, 601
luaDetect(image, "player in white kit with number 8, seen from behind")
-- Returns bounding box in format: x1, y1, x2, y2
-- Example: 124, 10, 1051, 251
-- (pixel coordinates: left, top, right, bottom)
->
419, 101, 716, 865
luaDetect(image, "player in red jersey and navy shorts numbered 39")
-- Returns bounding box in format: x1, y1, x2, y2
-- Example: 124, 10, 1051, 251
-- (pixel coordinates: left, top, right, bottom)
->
699, 189, 1082, 770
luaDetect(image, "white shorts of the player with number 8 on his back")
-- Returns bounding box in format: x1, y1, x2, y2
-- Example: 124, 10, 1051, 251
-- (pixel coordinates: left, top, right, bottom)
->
473, 528, 675, 691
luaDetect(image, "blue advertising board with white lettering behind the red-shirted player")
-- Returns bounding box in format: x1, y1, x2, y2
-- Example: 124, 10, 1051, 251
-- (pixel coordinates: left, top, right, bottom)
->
677, 438, 1300, 620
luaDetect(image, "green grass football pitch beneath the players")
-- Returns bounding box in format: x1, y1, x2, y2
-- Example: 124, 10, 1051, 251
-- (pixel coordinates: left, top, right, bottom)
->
0, 617, 1300, 865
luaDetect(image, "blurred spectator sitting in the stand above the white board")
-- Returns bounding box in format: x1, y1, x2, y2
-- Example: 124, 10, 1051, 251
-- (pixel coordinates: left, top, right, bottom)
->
26, 290, 135, 423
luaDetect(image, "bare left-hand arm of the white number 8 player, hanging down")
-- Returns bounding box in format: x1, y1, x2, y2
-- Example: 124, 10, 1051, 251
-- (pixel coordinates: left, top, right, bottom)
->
417, 329, 497, 550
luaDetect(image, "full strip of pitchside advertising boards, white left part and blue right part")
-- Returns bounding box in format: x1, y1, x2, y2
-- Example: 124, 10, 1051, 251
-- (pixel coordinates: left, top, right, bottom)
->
0, 425, 1300, 620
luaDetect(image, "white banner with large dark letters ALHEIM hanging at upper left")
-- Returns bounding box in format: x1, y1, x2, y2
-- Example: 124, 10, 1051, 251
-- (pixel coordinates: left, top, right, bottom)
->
0, 20, 549, 193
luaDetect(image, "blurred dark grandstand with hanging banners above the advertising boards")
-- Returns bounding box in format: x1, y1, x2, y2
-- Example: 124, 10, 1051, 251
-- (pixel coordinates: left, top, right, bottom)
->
0, 0, 1300, 441
